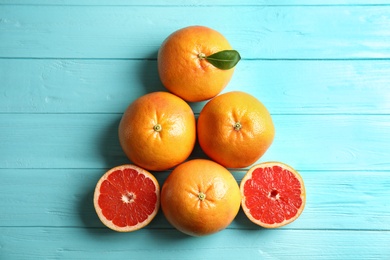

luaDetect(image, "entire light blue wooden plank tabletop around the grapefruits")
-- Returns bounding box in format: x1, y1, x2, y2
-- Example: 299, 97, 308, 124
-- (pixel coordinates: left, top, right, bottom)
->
0, 0, 390, 260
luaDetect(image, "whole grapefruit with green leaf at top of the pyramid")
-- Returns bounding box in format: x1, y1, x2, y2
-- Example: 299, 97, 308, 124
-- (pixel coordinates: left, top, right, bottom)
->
157, 26, 241, 102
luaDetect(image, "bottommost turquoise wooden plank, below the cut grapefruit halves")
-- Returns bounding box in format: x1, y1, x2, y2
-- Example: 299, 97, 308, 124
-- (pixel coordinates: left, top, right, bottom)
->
0, 227, 390, 259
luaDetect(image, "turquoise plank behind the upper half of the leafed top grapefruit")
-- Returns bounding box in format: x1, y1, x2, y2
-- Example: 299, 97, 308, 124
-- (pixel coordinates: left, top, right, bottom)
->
0, 5, 390, 59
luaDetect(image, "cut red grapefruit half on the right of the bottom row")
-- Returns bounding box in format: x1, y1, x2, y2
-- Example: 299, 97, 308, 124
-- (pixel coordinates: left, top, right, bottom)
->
240, 162, 306, 228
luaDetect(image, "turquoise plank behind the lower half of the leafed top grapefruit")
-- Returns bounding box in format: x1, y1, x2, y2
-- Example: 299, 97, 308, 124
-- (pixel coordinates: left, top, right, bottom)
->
0, 59, 390, 114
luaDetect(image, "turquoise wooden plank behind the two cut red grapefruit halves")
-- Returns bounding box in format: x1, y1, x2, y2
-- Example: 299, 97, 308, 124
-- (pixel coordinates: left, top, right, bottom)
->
0, 169, 390, 231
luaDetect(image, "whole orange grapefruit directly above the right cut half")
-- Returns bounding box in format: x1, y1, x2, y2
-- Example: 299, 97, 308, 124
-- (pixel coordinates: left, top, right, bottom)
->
197, 91, 275, 168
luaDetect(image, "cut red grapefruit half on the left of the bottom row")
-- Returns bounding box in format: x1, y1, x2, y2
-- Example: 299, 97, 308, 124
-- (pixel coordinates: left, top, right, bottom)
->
93, 164, 160, 232
